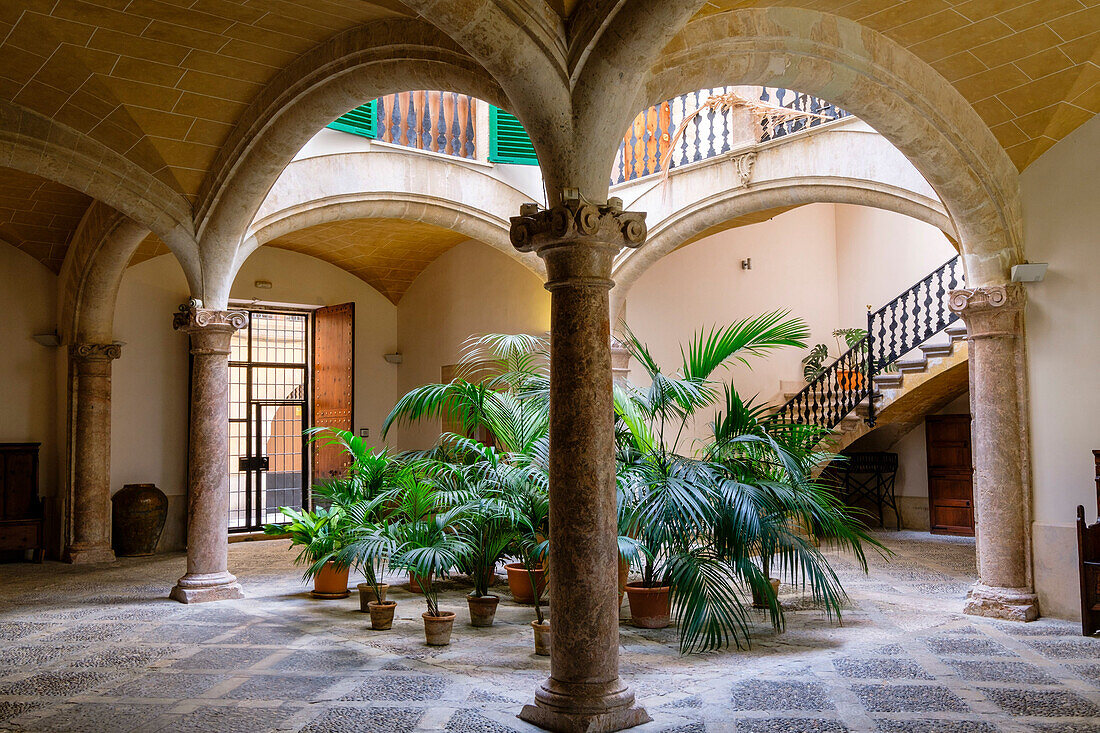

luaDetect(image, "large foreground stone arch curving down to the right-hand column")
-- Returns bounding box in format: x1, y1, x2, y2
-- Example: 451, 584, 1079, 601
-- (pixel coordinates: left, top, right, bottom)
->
638, 8, 1022, 286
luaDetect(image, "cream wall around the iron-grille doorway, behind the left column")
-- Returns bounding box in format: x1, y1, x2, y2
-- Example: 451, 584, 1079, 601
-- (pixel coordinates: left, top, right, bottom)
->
111, 248, 397, 549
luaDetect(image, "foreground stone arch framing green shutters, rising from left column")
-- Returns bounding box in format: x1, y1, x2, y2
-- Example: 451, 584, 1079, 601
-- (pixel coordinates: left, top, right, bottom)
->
196, 20, 505, 307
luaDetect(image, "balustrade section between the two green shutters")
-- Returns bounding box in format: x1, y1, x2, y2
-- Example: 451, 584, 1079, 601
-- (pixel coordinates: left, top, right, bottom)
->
375, 91, 476, 158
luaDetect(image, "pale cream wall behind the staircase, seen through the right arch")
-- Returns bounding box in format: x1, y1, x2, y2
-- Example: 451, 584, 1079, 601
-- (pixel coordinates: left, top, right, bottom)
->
626, 204, 955, 444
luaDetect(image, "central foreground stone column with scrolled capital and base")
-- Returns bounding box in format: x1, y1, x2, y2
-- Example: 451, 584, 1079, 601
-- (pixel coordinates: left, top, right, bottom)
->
512, 198, 650, 732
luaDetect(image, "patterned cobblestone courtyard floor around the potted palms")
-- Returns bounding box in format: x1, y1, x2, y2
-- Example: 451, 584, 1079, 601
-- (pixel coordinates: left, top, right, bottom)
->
0, 533, 1100, 733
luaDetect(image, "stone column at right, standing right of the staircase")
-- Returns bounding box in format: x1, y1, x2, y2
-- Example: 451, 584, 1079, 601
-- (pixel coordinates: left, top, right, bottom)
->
950, 283, 1038, 621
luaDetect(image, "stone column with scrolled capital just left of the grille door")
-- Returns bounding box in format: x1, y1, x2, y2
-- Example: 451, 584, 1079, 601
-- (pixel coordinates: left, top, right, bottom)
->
172, 305, 249, 603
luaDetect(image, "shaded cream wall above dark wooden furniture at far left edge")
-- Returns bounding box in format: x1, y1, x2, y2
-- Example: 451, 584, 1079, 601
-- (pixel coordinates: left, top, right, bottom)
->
0, 242, 65, 545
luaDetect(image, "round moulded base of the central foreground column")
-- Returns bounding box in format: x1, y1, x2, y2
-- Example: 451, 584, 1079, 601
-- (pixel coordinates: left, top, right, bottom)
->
519, 678, 653, 733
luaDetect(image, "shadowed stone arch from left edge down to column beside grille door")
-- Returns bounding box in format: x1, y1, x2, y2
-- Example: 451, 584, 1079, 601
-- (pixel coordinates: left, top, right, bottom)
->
0, 100, 200, 288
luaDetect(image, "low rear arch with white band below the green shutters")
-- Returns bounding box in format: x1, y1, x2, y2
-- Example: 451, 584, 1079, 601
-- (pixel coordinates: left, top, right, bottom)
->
233, 151, 546, 277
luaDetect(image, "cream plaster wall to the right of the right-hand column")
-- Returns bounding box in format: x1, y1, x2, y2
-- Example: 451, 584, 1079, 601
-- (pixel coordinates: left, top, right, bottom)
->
1020, 111, 1100, 617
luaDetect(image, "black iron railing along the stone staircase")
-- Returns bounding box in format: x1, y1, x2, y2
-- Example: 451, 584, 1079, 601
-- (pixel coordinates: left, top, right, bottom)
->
776, 256, 965, 429
